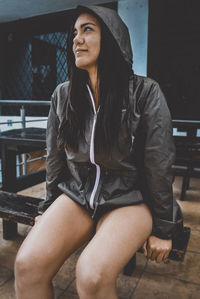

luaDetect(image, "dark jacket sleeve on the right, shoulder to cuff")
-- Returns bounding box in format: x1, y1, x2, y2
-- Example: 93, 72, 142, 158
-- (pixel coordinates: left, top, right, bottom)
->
143, 82, 177, 239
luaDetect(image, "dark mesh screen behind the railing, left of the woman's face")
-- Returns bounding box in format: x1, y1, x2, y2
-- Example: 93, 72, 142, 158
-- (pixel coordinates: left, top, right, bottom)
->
2, 32, 67, 115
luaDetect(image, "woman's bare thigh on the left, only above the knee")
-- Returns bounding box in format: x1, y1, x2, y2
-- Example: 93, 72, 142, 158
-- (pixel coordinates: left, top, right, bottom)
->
18, 194, 93, 277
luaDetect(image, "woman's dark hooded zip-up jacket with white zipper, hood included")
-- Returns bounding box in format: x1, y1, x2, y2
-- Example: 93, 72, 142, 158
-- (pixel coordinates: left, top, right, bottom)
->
39, 6, 182, 239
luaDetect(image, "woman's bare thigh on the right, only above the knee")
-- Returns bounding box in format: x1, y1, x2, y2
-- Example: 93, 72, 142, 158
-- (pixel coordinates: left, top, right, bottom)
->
79, 204, 152, 279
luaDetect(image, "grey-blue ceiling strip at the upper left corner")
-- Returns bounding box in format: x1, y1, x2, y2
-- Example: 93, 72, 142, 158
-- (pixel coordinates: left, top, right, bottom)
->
0, 0, 117, 23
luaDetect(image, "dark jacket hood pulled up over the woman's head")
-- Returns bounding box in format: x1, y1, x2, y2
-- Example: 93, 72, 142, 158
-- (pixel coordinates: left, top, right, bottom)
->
77, 5, 133, 68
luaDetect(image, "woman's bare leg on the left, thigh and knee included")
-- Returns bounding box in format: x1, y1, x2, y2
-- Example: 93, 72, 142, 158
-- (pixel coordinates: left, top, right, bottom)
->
15, 194, 94, 299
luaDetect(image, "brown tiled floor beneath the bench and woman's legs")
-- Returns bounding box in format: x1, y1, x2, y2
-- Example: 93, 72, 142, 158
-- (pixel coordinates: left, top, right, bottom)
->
0, 178, 200, 299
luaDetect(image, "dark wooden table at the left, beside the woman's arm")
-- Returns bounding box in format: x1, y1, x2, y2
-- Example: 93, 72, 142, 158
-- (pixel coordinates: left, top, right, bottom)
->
0, 128, 46, 239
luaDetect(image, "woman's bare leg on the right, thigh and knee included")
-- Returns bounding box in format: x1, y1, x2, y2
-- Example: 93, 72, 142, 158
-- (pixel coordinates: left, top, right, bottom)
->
76, 204, 152, 299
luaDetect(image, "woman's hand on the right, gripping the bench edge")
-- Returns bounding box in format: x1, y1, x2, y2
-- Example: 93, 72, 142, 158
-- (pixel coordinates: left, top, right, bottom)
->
142, 236, 172, 263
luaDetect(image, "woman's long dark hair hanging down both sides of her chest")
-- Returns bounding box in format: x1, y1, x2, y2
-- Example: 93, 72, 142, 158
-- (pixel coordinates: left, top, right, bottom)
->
59, 10, 133, 154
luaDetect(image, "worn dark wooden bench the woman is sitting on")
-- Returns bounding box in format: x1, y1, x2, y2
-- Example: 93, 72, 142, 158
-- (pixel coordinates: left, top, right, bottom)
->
0, 191, 190, 276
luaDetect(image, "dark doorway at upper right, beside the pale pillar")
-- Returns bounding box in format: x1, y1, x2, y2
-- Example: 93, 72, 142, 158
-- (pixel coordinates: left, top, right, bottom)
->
148, 0, 200, 120
